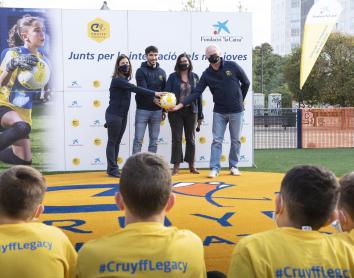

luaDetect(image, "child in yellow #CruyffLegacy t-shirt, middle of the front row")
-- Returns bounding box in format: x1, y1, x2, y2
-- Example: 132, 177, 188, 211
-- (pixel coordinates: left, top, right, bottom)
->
76, 153, 206, 278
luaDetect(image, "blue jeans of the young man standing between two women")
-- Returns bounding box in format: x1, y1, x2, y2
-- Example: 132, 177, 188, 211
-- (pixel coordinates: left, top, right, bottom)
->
133, 109, 162, 154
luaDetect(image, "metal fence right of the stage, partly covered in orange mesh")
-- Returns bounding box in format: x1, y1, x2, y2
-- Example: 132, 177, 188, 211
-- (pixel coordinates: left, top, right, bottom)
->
254, 108, 354, 149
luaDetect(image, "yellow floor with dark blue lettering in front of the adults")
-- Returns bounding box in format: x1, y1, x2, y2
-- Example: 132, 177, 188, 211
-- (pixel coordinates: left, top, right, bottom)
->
40, 170, 334, 272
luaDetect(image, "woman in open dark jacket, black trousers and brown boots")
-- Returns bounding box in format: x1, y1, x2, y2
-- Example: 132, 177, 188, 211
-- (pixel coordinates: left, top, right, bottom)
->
165, 53, 203, 175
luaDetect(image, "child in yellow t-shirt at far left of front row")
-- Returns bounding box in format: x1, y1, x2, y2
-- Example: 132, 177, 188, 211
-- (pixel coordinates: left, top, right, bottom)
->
0, 166, 77, 278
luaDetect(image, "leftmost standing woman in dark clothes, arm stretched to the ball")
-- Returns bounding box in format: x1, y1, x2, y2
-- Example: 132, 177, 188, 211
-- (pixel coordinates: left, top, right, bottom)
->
105, 55, 163, 178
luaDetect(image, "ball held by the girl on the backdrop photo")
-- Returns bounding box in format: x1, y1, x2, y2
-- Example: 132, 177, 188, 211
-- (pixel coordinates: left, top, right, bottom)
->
17, 58, 50, 90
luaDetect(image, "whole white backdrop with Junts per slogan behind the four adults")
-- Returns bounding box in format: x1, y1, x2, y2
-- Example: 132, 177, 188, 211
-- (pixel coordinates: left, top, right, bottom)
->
0, 9, 253, 171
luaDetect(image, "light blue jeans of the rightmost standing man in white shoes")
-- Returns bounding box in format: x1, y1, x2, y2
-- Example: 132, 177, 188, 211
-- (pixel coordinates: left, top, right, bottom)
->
210, 112, 244, 171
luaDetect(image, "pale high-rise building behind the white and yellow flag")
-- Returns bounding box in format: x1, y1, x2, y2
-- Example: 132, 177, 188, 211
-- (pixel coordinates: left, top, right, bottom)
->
271, 0, 354, 55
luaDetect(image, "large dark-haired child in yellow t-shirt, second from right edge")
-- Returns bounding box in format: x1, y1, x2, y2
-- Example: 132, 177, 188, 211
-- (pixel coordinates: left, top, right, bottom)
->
228, 165, 354, 278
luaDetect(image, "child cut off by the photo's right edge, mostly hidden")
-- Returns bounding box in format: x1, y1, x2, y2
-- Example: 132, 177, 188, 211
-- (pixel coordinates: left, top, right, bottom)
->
334, 172, 354, 246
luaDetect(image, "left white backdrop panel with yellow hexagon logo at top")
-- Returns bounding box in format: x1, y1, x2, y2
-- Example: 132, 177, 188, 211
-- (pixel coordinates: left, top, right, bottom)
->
63, 10, 130, 171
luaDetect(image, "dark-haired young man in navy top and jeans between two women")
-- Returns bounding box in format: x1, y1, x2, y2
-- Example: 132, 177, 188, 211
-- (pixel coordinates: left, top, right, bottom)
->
133, 46, 166, 154
